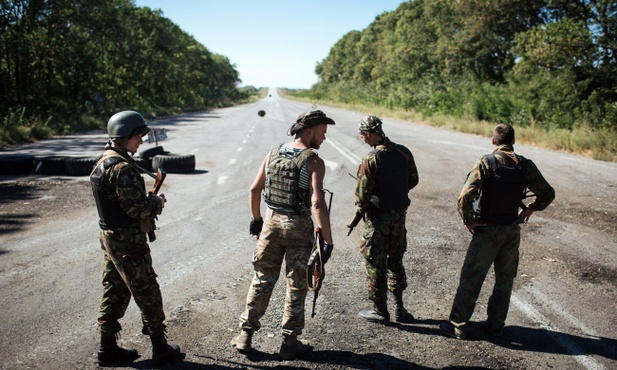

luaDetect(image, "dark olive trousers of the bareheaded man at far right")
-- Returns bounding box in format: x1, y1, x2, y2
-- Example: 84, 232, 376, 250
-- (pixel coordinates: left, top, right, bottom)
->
450, 225, 521, 328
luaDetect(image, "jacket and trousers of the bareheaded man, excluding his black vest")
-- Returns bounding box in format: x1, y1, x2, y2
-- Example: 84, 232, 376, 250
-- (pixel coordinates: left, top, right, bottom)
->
449, 145, 555, 330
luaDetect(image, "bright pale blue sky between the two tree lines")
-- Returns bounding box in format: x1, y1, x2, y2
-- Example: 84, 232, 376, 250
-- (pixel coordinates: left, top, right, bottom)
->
134, 0, 405, 89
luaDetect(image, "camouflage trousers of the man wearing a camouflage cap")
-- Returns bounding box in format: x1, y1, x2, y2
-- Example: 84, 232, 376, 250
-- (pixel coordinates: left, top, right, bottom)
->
360, 210, 407, 303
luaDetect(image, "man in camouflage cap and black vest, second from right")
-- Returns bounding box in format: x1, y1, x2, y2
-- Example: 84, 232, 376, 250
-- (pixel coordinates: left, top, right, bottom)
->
356, 116, 419, 323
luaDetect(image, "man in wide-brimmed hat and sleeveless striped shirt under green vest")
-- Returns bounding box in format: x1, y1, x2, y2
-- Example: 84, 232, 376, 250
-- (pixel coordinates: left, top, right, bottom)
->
231, 110, 334, 359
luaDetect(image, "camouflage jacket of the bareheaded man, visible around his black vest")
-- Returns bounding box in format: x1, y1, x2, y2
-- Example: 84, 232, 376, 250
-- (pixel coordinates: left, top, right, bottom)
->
458, 145, 555, 225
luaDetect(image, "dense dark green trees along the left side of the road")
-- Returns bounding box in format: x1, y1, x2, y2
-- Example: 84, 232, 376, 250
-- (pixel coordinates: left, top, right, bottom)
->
0, 0, 256, 144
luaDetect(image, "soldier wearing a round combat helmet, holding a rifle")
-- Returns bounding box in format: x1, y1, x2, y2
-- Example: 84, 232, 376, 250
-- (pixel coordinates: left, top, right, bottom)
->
90, 111, 181, 366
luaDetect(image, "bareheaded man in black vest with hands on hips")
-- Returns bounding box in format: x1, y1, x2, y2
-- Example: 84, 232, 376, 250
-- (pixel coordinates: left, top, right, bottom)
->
440, 123, 555, 339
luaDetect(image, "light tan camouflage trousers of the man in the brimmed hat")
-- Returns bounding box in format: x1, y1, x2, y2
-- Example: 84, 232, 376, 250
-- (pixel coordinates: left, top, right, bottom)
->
240, 209, 314, 335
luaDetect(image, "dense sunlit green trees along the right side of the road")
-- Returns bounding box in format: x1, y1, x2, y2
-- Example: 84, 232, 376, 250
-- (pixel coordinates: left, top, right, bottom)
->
303, 0, 617, 133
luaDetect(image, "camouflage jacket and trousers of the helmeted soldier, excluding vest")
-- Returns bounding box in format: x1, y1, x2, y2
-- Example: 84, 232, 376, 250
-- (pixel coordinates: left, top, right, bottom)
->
91, 150, 165, 336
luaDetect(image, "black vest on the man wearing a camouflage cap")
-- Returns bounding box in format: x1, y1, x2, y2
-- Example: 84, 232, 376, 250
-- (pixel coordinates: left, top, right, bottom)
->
371, 144, 409, 211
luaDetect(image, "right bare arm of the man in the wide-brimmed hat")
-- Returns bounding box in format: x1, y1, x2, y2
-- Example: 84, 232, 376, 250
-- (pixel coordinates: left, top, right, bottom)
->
306, 156, 333, 244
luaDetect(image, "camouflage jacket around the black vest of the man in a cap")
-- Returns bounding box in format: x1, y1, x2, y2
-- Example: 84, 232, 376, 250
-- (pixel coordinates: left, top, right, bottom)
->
355, 138, 419, 213
